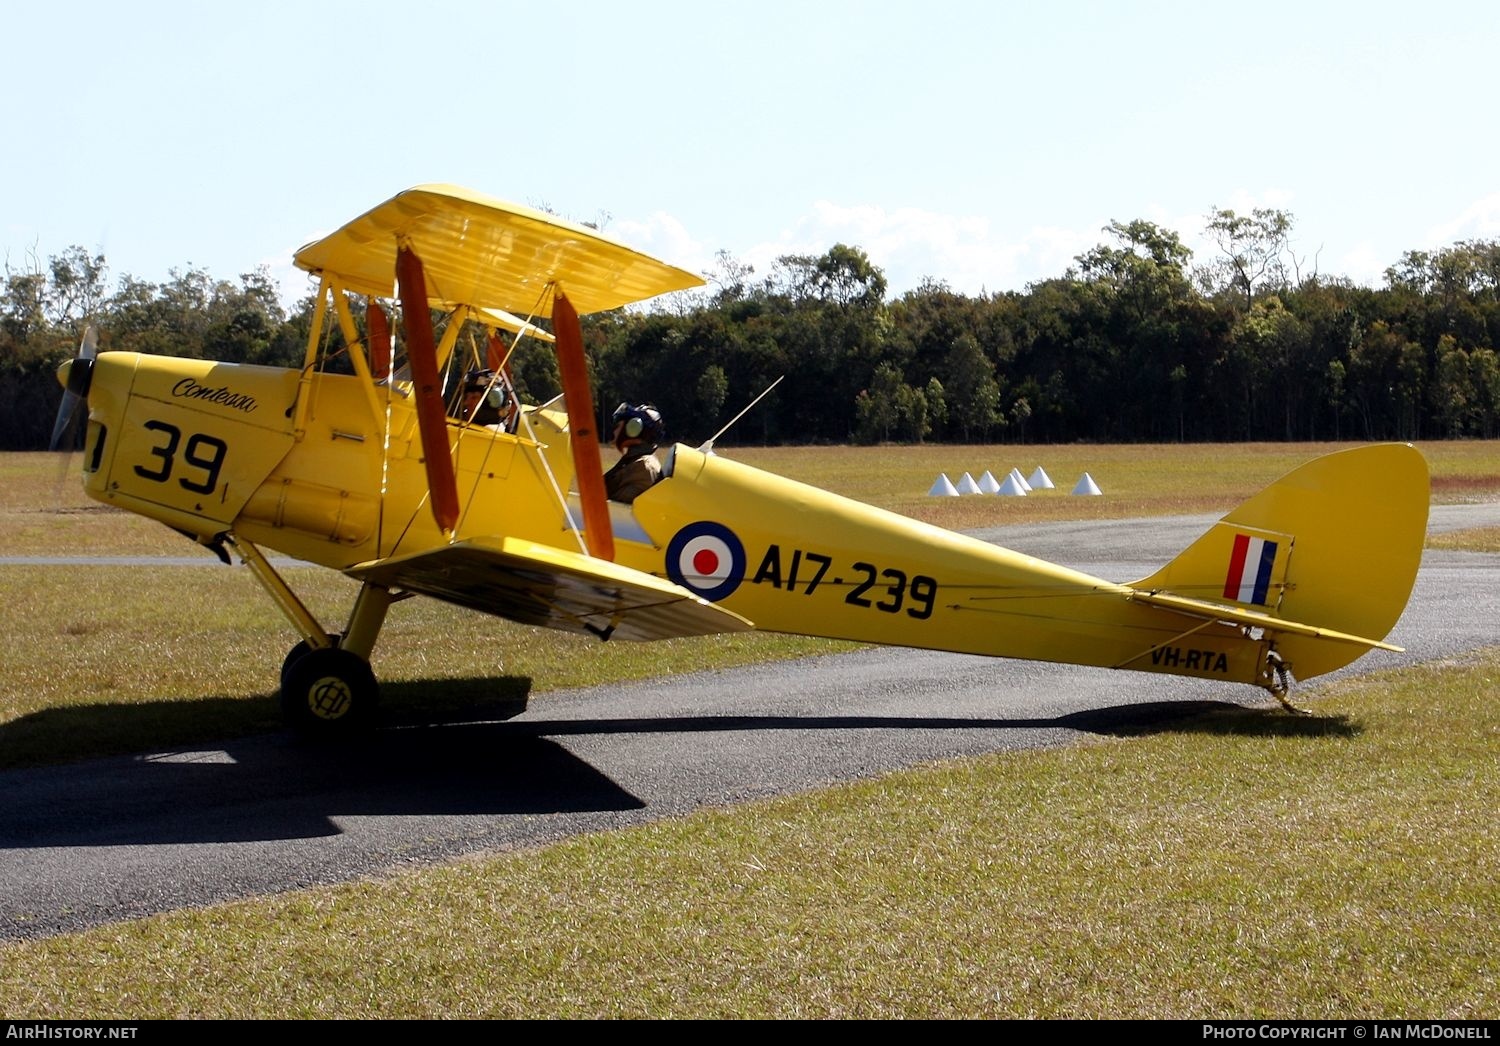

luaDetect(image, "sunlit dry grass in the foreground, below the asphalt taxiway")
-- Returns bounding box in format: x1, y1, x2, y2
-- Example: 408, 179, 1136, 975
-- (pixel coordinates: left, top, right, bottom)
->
0, 656, 1500, 1020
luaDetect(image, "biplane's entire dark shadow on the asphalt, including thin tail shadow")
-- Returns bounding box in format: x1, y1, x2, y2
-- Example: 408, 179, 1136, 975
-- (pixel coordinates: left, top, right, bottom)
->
0, 681, 1359, 849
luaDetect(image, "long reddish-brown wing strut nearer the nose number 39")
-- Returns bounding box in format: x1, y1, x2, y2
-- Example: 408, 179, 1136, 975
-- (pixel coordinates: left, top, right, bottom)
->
396, 246, 459, 534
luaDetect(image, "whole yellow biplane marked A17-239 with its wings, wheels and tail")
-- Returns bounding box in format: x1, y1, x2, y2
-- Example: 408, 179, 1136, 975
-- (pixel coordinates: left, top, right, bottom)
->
49, 185, 1428, 734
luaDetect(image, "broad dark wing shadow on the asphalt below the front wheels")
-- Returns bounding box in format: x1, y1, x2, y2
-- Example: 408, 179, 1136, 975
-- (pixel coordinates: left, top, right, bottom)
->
0, 723, 645, 849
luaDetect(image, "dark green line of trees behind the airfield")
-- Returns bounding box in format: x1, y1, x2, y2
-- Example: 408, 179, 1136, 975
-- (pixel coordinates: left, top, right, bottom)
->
0, 209, 1500, 449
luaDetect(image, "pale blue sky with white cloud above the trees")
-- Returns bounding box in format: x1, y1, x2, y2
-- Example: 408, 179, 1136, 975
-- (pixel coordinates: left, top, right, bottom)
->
0, 0, 1500, 306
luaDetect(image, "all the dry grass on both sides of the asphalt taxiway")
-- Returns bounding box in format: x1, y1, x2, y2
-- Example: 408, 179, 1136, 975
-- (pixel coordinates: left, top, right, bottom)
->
0, 443, 1500, 1019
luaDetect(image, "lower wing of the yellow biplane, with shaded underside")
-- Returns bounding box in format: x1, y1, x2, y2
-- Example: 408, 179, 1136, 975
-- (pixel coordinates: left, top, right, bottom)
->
347, 537, 755, 639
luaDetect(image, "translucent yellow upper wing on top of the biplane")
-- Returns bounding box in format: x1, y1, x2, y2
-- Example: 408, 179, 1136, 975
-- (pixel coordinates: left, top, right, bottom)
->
294, 185, 704, 317
